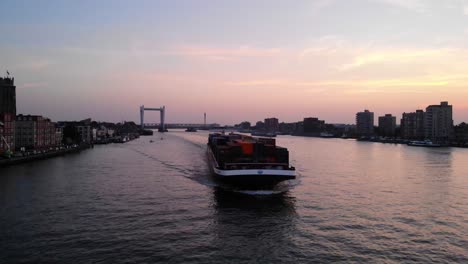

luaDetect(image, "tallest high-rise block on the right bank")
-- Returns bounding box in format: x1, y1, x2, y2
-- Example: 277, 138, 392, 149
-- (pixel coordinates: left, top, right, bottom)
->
424, 102, 453, 144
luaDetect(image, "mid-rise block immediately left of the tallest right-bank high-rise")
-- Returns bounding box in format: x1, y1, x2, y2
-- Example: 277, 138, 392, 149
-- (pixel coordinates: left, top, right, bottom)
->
400, 110, 425, 140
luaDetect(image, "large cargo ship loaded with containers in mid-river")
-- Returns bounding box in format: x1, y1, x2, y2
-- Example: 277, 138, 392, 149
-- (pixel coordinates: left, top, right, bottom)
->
207, 133, 296, 189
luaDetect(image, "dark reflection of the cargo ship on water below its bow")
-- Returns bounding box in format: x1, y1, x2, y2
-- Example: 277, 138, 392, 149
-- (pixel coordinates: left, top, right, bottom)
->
213, 188, 297, 263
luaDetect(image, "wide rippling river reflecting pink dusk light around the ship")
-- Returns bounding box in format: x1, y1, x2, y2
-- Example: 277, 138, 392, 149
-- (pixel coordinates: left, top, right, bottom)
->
0, 131, 468, 263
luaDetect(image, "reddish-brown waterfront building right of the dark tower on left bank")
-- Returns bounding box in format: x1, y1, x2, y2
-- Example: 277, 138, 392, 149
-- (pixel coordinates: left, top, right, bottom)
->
15, 115, 61, 150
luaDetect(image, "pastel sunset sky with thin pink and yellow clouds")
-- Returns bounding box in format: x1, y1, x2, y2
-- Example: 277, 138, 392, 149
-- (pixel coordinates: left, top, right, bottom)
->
0, 0, 468, 124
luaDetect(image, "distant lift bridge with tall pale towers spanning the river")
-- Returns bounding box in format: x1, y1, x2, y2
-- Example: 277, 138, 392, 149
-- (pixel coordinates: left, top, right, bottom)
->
140, 105, 219, 132
